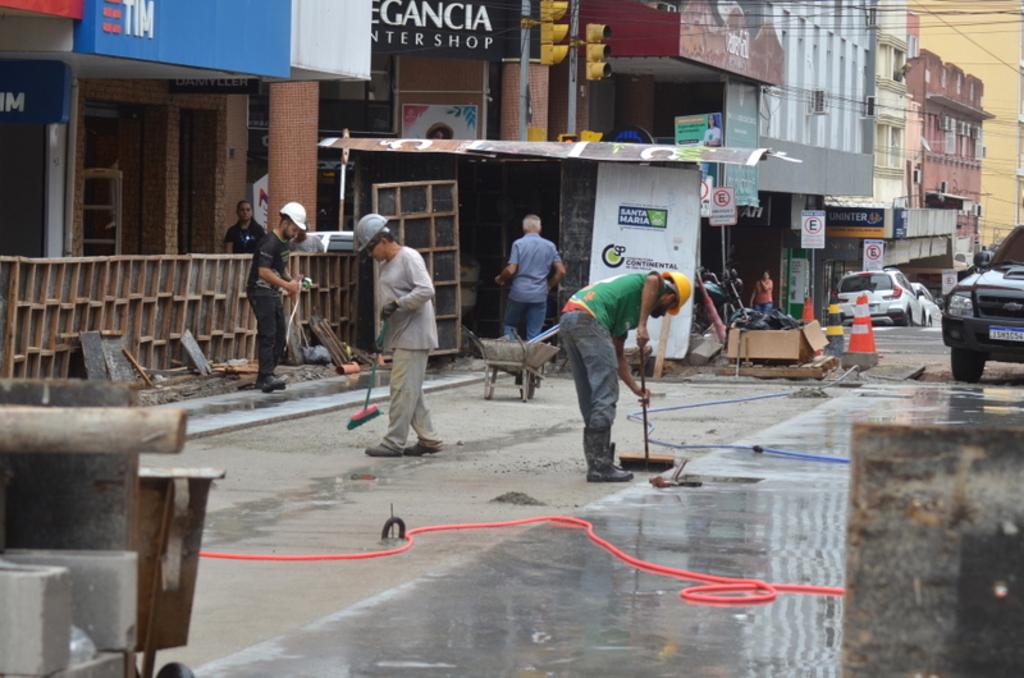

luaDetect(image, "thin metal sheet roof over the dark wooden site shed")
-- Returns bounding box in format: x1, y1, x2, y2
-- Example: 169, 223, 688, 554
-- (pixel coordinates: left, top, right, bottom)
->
319, 138, 802, 165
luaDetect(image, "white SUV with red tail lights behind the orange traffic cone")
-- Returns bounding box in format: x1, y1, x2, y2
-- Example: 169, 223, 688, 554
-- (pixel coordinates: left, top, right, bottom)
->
838, 269, 928, 325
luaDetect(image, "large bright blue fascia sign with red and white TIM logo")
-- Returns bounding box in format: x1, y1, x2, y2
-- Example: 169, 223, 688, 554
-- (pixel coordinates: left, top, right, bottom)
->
75, 0, 292, 78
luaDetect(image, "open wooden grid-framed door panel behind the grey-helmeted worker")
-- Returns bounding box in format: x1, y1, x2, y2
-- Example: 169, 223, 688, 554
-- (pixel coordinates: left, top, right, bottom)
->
373, 181, 462, 355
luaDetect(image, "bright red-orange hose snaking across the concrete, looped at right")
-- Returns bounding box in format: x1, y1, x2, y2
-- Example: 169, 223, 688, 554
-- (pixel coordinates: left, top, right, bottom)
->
200, 515, 844, 605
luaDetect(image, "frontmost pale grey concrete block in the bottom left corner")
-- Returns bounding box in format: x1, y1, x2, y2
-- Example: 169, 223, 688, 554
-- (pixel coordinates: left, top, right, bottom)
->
0, 565, 71, 676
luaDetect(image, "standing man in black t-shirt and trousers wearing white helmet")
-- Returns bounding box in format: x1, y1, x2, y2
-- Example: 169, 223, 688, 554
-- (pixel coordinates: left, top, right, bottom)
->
246, 203, 306, 393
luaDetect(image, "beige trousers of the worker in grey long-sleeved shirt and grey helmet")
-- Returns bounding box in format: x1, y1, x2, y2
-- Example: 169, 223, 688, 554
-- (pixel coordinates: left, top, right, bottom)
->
384, 348, 441, 450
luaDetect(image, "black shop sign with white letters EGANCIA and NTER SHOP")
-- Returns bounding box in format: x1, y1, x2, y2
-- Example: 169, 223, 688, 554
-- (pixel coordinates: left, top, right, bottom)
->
370, 0, 519, 60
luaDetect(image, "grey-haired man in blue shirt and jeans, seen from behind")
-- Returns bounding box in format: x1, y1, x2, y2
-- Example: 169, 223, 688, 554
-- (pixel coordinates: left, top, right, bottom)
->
495, 214, 565, 341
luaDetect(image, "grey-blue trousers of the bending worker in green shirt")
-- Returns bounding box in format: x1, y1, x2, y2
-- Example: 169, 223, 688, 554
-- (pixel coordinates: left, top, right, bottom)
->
558, 310, 618, 429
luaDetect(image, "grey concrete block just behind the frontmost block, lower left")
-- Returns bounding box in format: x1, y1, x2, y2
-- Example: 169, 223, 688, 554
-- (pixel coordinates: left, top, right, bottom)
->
3, 549, 138, 650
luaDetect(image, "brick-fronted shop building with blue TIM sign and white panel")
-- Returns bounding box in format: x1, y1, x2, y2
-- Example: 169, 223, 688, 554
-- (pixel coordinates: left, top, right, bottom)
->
0, 0, 370, 257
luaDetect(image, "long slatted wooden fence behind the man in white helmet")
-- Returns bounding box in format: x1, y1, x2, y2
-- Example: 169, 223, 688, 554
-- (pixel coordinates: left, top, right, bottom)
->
0, 253, 358, 379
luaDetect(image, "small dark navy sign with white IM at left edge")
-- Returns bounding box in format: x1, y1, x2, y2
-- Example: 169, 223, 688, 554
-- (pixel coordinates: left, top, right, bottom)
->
0, 61, 71, 125
